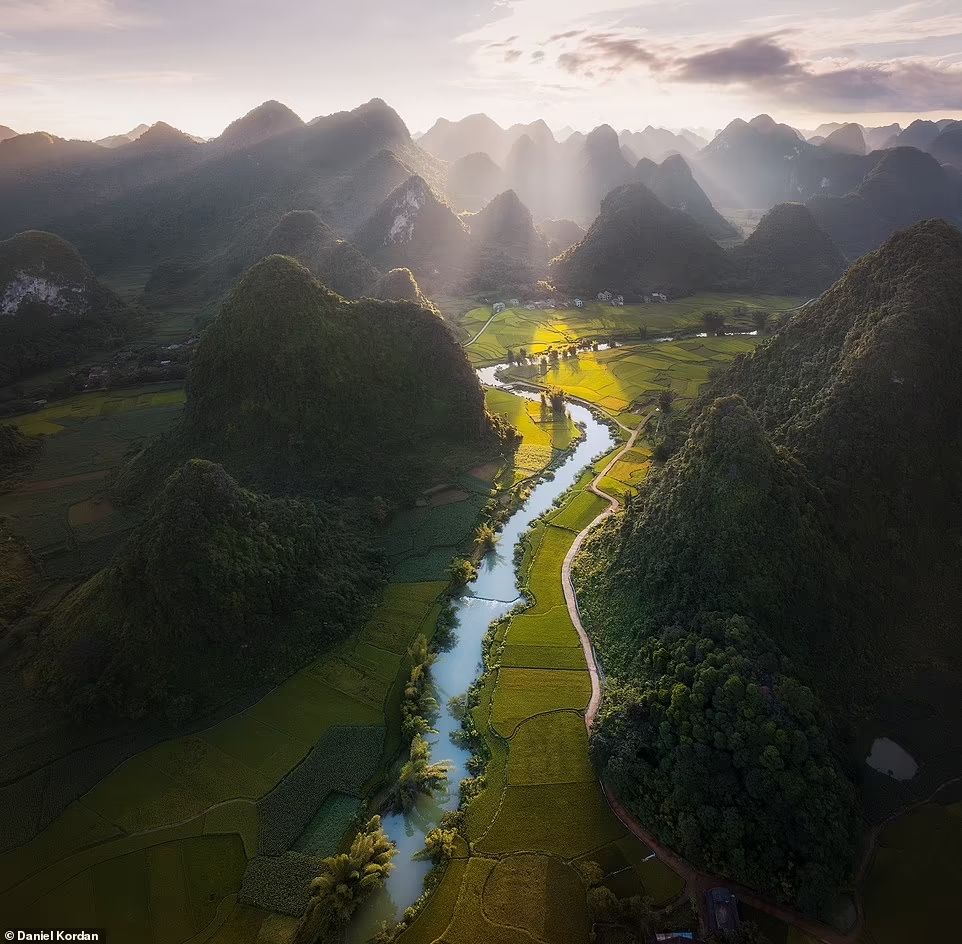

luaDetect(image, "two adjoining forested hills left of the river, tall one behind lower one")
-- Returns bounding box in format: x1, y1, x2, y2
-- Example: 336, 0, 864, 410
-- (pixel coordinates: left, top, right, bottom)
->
27, 256, 501, 722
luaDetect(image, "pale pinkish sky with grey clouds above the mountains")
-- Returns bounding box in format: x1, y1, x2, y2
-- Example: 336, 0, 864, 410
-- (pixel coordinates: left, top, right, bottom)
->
0, 0, 962, 138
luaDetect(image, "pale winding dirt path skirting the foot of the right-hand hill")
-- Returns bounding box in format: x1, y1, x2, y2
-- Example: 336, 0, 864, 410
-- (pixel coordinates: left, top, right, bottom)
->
561, 412, 871, 944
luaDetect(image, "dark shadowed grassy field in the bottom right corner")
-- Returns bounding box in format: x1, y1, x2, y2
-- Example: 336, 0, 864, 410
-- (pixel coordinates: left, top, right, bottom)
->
862, 803, 962, 944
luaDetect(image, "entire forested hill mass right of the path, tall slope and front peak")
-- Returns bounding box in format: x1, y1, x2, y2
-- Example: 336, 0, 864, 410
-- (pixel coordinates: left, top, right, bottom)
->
577, 221, 962, 911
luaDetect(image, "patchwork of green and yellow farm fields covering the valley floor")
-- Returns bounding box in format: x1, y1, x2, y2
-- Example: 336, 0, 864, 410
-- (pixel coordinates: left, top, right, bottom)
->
0, 298, 962, 944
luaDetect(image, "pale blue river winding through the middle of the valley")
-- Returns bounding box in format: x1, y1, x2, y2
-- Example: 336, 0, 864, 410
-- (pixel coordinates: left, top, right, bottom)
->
349, 365, 615, 944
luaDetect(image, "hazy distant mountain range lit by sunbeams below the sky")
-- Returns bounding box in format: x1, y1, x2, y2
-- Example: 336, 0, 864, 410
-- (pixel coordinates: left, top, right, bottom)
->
0, 99, 962, 322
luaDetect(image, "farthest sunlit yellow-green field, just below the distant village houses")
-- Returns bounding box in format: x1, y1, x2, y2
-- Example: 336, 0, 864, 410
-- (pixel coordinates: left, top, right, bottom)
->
449, 292, 805, 364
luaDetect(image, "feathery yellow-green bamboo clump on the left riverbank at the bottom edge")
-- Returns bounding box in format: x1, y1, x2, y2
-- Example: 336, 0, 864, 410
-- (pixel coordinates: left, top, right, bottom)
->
293, 816, 397, 944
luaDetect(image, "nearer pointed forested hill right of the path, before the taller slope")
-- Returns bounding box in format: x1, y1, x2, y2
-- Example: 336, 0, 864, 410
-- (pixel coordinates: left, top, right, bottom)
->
576, 397, 859, 912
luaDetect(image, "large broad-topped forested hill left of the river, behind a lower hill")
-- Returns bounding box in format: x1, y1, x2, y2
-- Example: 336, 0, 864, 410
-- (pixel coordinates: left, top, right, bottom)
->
131, 256, 496, 495
